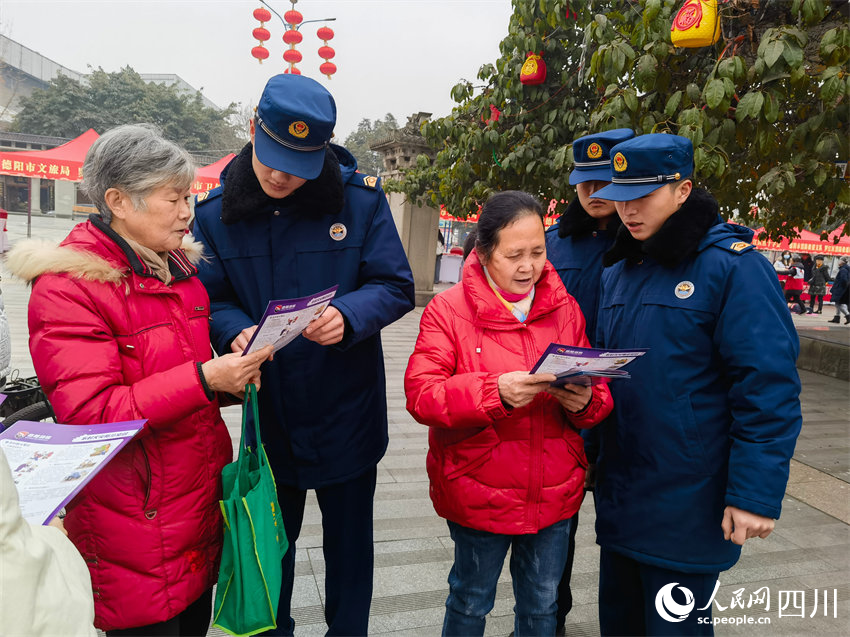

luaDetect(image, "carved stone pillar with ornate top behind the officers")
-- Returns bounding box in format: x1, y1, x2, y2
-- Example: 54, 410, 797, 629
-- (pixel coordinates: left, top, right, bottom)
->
370, 113, 440, 306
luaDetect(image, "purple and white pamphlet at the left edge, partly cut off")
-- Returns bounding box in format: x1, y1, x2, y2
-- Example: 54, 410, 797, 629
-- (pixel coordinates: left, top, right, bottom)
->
0, 420, 147, 524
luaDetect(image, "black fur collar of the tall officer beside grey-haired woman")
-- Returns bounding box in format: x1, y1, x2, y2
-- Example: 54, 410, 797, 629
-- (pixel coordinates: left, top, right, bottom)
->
221, 142, 345, 224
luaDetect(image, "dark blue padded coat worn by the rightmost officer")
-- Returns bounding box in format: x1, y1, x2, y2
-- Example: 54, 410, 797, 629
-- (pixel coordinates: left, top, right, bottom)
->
596, 194, 802, 573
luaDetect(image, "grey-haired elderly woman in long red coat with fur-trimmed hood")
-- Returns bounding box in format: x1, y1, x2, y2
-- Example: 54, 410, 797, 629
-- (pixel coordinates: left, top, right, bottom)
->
8, 126, 270, 635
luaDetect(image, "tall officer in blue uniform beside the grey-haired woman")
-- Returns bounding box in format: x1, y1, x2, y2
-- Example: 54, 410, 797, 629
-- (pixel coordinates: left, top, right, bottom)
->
194, 74, 414, 635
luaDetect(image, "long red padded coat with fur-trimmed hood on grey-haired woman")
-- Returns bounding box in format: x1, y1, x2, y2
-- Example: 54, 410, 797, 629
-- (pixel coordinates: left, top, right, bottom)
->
9, 219, 233, 630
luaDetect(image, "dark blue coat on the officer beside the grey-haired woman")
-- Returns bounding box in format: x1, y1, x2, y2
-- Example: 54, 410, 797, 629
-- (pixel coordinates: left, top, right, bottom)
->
194, 144, 414, 489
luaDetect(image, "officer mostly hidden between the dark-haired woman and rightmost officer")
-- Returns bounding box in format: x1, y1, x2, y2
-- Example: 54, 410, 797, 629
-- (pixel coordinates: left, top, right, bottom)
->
546, 128, 635, 631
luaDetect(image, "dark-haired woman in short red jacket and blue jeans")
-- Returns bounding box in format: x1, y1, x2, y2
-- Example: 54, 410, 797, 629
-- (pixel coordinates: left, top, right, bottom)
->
405, 191, 612, 636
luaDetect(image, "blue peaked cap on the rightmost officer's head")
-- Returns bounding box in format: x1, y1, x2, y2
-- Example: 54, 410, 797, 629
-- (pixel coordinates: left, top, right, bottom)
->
593, 133, 694, 201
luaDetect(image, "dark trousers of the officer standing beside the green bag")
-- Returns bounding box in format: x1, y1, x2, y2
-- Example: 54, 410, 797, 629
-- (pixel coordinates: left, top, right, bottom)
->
263, 468, 378, 637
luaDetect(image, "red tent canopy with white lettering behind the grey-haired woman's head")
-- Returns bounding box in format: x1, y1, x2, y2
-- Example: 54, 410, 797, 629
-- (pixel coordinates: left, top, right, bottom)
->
0, 128, 100, 181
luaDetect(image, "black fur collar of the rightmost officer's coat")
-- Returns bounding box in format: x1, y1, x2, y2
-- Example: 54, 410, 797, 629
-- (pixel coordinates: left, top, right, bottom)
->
602, 188, 719, 268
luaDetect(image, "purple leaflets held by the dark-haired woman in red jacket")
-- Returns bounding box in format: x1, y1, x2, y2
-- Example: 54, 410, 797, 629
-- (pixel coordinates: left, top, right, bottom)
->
530, 343, 649, 387
